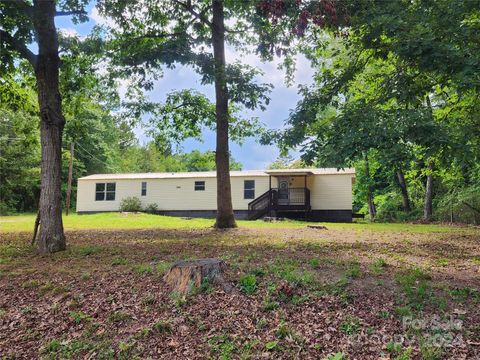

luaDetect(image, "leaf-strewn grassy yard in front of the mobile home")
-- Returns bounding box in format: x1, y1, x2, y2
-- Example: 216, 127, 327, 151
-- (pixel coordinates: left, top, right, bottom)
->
0, 213, 480, 360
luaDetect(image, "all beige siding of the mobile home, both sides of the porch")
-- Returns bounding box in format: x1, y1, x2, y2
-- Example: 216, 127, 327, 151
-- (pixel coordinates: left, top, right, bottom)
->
77, 172, 354, 212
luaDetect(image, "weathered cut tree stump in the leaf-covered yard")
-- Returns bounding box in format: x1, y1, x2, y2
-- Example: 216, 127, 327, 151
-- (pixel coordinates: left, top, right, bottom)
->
163, 259, 231, 294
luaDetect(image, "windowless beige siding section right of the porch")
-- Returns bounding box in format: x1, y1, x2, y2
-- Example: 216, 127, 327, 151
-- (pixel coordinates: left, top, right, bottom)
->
307, 174, 352, 210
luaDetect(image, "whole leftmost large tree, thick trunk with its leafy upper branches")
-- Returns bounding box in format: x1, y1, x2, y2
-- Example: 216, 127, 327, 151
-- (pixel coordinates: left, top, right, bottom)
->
0, 0, 86, 254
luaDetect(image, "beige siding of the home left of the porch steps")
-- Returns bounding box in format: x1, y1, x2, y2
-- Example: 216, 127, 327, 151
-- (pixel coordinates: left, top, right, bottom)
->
77, 176, 268, 211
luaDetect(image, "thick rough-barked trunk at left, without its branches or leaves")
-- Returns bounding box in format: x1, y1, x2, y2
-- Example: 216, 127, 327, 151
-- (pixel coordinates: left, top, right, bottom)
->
33, 0, 66, 254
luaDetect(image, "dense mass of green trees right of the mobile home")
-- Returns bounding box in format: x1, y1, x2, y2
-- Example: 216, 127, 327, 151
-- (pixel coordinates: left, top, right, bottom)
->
263, 0, 480, 224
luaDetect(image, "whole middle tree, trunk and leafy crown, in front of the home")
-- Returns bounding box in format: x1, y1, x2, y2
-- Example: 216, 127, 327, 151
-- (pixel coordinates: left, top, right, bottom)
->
99, 0, 278, 228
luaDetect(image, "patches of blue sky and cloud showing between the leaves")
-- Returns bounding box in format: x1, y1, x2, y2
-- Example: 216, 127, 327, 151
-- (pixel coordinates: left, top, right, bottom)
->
56, 6, 313, 170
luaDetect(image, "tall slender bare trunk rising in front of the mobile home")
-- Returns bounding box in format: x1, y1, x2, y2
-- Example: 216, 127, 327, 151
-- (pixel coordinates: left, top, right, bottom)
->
212, 0, 236, 228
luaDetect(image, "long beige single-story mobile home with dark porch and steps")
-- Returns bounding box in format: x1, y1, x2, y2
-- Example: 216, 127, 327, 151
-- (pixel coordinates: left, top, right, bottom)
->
77, 169, 355, 222
